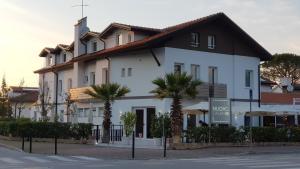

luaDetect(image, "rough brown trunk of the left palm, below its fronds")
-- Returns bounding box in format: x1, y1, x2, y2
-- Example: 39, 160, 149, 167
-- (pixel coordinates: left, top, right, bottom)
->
102, 101, 111, 143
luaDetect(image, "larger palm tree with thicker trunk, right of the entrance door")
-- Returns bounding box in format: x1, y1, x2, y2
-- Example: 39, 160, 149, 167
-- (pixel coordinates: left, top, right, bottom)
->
150, 72, 201, 143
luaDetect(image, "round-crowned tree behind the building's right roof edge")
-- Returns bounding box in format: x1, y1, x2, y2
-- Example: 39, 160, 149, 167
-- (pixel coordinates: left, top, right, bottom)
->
261, 53, 300, 85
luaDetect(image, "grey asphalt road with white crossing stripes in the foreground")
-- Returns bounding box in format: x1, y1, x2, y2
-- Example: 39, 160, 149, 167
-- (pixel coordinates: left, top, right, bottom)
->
0, 147, 300, 169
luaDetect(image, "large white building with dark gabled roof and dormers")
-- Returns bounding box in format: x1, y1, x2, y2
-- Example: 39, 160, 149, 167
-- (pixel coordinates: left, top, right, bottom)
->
35, 13, 271, 138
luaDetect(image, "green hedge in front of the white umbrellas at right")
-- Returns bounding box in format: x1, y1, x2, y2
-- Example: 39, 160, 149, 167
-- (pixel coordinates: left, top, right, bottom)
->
185, 127, 300, 143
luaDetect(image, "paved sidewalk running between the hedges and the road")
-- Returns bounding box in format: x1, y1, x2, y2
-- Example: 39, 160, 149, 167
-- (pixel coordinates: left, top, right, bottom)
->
0, 140, 300, 159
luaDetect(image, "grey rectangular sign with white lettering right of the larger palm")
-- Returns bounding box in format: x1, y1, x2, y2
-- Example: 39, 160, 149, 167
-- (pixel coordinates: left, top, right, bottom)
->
210, 98, 230, 124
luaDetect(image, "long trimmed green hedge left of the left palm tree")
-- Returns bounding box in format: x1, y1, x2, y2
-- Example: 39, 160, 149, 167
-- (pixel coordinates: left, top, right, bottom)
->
0, 120, 92, 139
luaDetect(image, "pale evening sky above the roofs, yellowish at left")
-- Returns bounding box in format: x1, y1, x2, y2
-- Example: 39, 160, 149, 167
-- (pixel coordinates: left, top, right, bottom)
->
0, 0, 300, 86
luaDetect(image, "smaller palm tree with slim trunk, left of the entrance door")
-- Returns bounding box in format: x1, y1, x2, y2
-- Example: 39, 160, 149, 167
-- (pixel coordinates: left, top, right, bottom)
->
85, 83, 130, 143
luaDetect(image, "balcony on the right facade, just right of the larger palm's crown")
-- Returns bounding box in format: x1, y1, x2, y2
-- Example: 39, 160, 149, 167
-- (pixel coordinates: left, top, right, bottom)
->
197, 83, 227, 98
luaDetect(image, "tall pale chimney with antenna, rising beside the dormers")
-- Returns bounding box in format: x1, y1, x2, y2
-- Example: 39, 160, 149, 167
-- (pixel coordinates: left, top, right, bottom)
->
74, 17, 90, 57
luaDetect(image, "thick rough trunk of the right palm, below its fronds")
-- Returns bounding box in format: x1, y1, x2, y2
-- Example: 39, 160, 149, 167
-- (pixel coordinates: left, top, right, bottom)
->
171, 97, 182, 143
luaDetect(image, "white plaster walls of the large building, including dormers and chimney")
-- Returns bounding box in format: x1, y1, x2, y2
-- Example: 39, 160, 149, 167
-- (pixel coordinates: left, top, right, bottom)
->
35, 14, 270, 138
